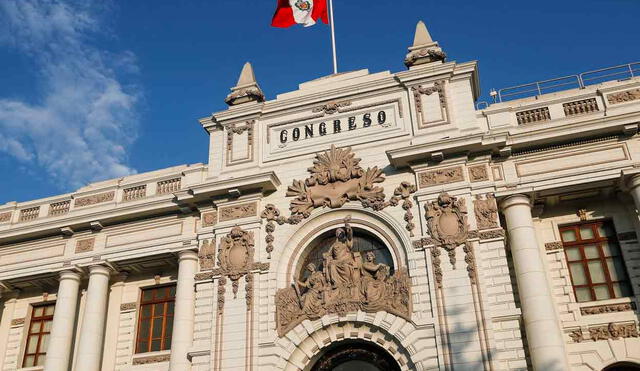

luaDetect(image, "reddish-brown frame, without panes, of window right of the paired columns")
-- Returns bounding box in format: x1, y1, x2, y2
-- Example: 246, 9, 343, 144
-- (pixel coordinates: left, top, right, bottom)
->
134, 282, 177, 355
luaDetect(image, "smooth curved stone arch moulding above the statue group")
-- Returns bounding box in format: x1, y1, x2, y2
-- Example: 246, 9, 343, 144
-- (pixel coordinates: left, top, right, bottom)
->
276, 205, 411, 288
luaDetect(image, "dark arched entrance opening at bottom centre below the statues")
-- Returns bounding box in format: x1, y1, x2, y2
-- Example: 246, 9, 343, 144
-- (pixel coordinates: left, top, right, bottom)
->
311, 340, 400, 371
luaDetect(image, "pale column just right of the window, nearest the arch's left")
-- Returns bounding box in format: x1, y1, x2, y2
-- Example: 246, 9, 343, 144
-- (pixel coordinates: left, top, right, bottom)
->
169, 250, 198, 371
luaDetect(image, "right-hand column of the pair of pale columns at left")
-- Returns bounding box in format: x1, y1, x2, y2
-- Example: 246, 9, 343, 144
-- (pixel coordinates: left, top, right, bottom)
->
75, 265, 110, 371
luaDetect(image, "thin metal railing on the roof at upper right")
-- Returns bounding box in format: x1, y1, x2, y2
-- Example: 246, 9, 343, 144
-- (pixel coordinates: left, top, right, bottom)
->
491, 62, 640, 102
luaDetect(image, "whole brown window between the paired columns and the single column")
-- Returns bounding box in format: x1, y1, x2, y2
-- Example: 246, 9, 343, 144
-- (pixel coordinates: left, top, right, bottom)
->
136, 285, 176, 353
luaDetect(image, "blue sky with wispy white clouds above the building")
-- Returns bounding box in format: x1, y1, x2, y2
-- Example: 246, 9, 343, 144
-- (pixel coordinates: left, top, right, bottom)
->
0, 0, 640, 204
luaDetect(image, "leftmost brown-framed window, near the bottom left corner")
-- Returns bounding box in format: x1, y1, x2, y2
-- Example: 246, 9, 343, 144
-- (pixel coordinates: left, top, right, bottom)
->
22, 303, 55, 367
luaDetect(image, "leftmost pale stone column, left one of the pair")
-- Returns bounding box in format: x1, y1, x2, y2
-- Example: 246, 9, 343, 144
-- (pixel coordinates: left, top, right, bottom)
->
44, 271, 80, 371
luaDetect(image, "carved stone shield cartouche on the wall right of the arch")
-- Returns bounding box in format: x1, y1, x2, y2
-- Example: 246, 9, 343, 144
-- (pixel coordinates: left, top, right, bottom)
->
424, 192, 469, 269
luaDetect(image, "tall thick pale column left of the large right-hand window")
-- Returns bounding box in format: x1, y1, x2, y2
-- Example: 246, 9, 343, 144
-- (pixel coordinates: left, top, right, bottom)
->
501, 195, 569, 370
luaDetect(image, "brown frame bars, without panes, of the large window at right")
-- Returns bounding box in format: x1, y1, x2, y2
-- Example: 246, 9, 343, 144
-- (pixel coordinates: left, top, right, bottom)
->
558, 219, 633, 303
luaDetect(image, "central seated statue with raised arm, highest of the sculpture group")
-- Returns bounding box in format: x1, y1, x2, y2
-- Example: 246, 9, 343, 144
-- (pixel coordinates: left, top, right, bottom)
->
323, 217, 360, 289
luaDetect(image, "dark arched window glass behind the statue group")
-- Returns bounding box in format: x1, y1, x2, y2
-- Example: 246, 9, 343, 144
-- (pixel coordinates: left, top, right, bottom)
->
296, 228, 395, 281
